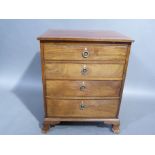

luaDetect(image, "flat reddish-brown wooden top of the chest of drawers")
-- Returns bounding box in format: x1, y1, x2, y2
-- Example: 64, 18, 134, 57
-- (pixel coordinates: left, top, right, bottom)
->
37, 30, 133, 43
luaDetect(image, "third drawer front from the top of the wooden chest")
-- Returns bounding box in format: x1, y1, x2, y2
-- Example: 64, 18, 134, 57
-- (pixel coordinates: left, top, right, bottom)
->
46, 80, 121, 97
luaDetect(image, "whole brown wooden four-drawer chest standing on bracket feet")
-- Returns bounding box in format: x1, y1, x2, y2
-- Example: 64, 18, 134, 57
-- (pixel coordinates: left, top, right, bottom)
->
38, 30, 132, 133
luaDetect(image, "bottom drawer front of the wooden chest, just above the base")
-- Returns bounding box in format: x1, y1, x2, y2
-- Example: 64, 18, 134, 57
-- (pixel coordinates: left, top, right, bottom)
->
46, 99, 119, 118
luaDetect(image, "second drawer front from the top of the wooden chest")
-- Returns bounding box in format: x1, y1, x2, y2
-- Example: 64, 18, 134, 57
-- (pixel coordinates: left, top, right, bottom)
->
45, 63, 124, 80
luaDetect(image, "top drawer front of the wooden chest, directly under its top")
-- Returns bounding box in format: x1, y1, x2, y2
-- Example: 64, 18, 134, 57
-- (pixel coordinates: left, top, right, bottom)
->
44, 42, 127, 61
